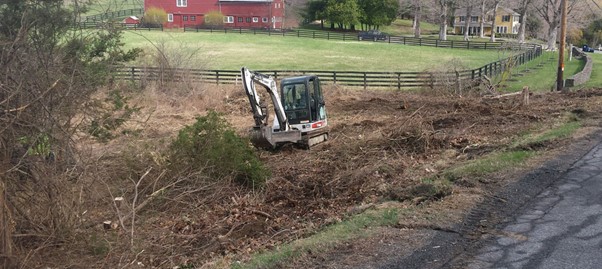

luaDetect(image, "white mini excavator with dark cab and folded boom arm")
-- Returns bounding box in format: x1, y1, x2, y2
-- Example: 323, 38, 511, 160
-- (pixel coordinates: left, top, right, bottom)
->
241, 67, 328, 149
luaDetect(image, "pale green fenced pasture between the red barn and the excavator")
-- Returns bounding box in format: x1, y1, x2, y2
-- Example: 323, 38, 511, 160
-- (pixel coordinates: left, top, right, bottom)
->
124, 31, 500, 71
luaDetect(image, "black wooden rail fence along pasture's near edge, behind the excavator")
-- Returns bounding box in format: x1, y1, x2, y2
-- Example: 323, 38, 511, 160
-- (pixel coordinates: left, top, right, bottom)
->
114, 45, 542, 89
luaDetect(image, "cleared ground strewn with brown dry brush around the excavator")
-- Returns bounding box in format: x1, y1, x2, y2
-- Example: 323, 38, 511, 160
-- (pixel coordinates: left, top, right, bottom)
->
24, 80, 597, 267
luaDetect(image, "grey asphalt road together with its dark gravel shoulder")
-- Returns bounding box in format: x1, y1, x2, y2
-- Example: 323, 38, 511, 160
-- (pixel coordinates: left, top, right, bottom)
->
380, 132, 602, 269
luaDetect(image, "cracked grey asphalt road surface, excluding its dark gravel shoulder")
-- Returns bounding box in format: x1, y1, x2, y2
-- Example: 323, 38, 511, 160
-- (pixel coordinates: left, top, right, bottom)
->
467, 141, 602, 269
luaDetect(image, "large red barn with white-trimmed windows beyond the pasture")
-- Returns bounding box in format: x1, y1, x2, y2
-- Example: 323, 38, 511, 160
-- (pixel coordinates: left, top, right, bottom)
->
144, 0, 284, 29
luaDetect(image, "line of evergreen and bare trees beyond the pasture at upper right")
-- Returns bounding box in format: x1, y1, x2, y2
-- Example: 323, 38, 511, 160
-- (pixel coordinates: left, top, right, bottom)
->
301, 0, 602, 49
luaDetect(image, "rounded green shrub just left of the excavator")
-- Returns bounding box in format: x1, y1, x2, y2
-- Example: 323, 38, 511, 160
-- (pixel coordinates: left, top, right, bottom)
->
170, 111, 270, 187
